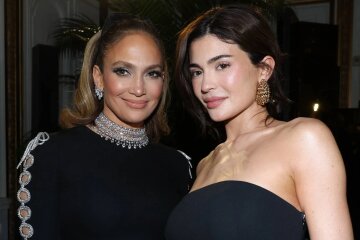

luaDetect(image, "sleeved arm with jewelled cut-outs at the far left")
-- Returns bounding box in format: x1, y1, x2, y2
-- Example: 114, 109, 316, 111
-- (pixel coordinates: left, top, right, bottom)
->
18, 133, 59, 240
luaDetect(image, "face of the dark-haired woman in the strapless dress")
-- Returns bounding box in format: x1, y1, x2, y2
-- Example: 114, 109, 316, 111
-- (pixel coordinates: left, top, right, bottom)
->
189, 34, 261, 121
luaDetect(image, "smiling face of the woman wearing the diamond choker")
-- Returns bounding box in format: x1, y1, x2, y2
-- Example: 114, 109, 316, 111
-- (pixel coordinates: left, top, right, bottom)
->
93, 32, 164, 127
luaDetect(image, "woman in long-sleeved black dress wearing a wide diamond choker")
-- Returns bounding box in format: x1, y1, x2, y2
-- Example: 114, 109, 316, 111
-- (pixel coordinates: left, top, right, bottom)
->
17, 14, 190, 240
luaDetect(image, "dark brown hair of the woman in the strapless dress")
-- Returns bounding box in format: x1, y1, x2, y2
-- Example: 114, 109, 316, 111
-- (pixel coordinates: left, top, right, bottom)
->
175, 4, 288, 137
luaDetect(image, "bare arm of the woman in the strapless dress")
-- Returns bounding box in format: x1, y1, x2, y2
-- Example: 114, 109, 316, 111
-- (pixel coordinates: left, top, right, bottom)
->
292, 119, 354, 240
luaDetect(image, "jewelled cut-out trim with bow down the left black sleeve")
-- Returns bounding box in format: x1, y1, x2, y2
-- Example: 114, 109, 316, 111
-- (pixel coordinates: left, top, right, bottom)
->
16, 132, 50, 240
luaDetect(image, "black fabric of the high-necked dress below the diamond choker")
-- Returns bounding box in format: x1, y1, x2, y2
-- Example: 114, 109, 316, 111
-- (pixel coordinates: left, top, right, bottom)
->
27, 126, 189, 240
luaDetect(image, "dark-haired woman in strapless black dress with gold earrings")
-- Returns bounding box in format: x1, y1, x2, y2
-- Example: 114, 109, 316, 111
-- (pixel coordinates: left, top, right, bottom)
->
166, 5, 353, 240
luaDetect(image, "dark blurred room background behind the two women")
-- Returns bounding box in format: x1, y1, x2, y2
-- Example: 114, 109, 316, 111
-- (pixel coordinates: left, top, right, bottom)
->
0, 0, 360, 240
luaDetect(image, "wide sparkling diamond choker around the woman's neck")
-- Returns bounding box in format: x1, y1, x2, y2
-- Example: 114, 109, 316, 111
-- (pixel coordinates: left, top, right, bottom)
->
93, 112, 149, 149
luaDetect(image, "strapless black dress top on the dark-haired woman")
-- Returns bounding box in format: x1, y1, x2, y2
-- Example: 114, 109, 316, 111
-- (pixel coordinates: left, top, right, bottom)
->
165, 181, 305, 240
